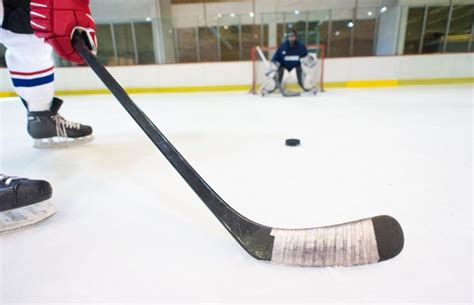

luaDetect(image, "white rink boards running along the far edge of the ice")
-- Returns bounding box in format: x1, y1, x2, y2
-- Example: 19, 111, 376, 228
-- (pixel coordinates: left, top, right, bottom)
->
0, 53, 474, 93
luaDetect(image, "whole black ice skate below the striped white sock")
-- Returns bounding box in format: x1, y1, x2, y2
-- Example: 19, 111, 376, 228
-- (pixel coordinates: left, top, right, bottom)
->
23, 98, 93, 148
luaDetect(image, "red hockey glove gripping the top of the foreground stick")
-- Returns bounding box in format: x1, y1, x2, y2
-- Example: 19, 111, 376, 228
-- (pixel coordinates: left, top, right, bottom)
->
30, 0, 97, 63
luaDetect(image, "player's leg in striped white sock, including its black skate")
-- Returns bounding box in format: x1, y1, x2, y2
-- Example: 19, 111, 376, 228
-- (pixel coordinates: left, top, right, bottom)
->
0, 29, 93, 148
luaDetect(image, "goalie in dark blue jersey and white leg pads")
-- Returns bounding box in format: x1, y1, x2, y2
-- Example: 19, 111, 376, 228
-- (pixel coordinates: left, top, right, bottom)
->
260, 30, 318, 96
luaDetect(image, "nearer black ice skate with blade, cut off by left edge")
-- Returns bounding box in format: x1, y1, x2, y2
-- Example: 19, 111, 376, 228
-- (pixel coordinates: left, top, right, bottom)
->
0, 174, 56, 234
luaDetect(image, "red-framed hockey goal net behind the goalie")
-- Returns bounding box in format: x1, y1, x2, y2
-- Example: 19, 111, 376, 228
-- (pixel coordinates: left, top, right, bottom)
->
250, 45, 326, 94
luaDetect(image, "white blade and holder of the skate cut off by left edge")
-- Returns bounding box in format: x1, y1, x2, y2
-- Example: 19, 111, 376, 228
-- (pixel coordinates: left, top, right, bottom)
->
0, 201, 56, 235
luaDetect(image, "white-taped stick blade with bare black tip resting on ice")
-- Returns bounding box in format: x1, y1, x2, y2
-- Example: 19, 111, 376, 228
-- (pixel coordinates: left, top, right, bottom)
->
270, 216, 404, 267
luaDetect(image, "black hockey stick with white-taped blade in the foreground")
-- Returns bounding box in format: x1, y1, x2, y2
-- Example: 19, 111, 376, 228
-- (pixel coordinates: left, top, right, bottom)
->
73, 36, 404, 267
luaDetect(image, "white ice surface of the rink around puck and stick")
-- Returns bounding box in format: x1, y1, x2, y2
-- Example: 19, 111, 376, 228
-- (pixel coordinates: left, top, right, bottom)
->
0, 85, 474, 304
